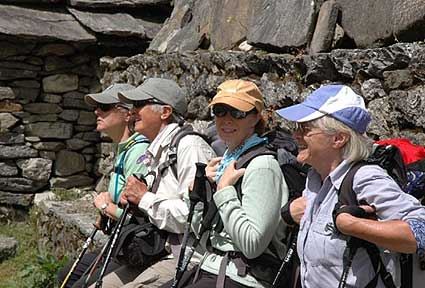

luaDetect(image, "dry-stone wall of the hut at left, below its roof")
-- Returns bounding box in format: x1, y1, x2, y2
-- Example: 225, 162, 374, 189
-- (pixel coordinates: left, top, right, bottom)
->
0, 39, 105, 220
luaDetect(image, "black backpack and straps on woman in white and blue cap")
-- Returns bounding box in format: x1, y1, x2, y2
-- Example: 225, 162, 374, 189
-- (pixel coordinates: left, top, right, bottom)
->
334, 145, 425, 288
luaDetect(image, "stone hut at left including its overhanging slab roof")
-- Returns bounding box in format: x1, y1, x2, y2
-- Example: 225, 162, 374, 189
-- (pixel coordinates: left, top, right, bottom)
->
0, 0, 171, 221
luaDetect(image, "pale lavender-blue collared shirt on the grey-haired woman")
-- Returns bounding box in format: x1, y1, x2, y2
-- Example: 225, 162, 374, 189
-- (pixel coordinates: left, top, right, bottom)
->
297, 161, 425, 288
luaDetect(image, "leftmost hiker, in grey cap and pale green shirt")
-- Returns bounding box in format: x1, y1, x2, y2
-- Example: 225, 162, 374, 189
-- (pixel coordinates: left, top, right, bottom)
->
58, 83, 149, 287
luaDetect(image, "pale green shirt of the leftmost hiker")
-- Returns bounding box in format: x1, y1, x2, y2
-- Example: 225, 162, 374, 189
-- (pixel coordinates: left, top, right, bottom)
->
108, 133, 149, 217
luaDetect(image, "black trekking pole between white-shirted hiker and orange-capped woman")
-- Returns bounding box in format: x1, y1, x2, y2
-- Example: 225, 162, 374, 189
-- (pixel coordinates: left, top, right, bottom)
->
171, 163, 207, 288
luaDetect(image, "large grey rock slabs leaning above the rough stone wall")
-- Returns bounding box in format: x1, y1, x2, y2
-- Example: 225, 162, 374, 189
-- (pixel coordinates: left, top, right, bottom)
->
149, 0, 425, 53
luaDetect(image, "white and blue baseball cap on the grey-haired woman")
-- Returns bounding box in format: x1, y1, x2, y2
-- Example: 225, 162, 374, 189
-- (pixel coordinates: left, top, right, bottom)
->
276, 85, 371, 133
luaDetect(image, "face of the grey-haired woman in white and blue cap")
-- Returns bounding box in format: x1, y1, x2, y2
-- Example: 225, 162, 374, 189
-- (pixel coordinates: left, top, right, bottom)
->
293, 122, 335, 168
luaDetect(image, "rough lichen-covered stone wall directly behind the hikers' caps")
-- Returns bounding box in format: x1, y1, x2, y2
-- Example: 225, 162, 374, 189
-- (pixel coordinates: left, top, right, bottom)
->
101, 43, 425, 145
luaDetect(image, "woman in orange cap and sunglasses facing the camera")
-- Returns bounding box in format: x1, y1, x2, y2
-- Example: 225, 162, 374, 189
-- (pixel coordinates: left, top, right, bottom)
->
161, 80, 288, 288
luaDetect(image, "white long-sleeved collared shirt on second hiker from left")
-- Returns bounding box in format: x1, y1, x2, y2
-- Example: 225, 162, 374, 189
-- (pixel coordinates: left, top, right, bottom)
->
139, 123, 215, 234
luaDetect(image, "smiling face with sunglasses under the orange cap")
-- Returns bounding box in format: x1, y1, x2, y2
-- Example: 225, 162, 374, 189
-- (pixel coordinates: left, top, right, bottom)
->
213, 104, 261, 151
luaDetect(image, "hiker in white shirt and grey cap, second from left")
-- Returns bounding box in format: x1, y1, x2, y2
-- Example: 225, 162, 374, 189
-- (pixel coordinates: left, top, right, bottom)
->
90, 78, 215, 288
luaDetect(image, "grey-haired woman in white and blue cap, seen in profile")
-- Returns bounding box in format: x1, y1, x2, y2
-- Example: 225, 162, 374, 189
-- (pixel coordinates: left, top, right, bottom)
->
277, 85, 425, 287
